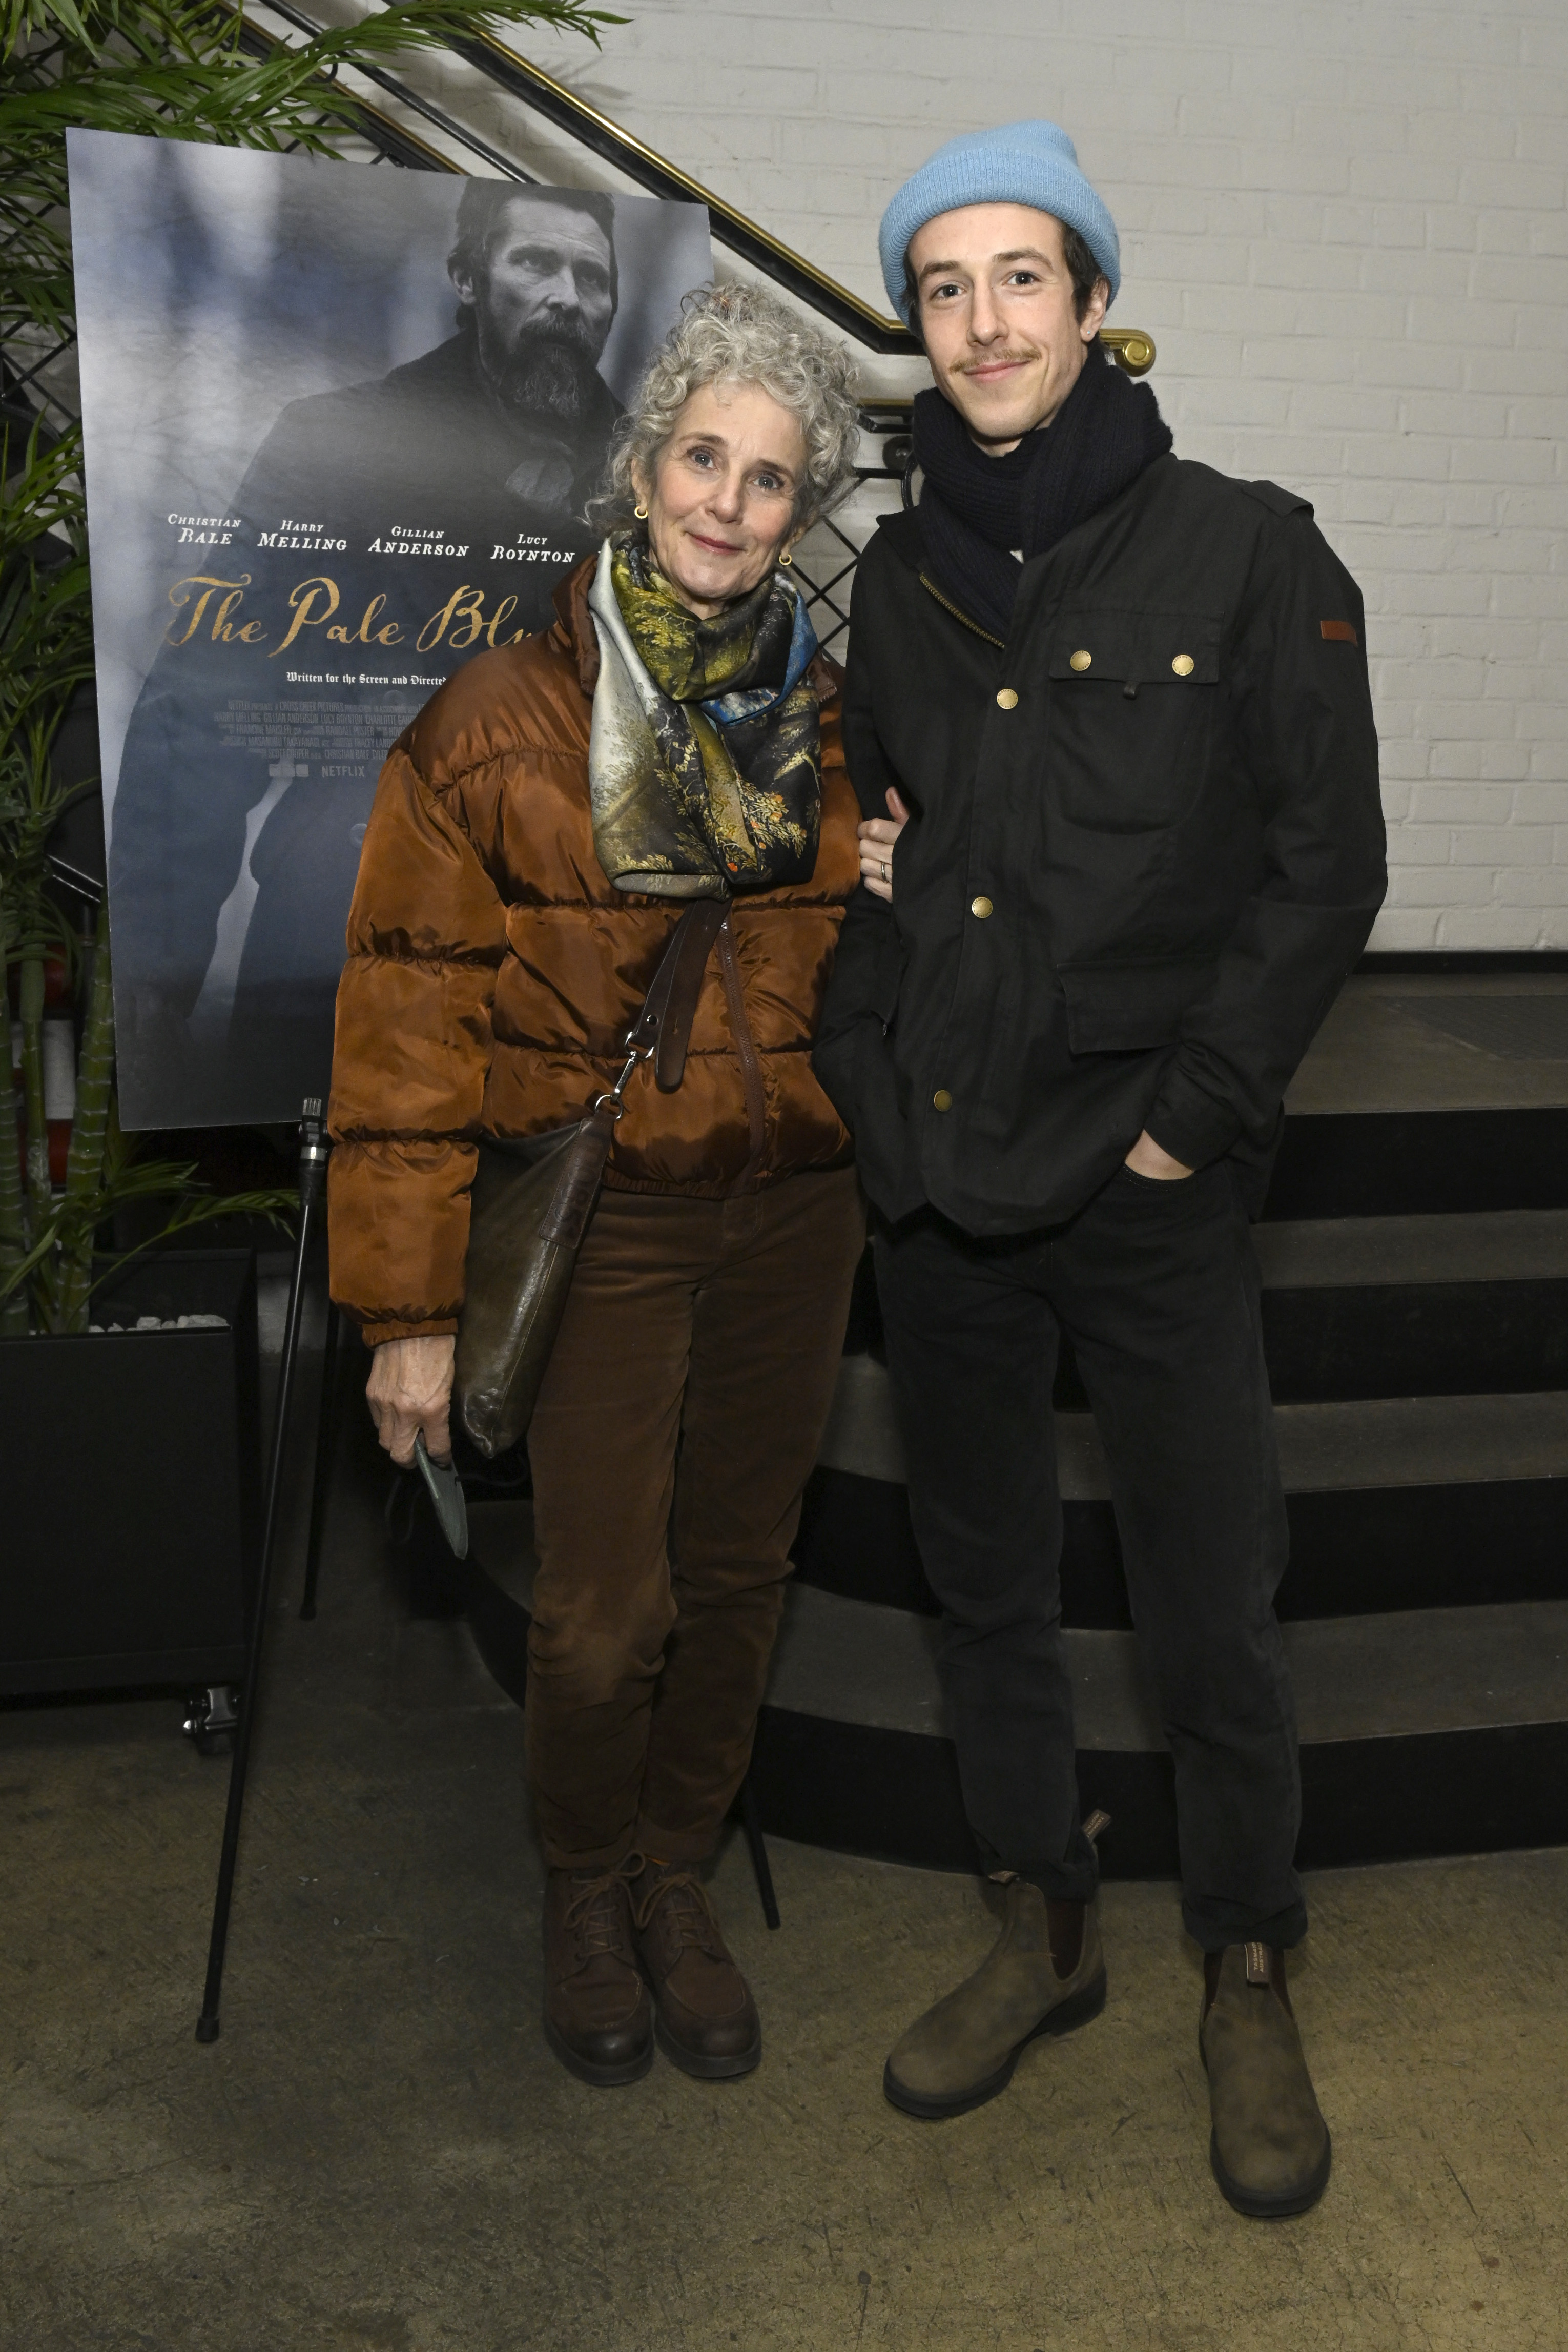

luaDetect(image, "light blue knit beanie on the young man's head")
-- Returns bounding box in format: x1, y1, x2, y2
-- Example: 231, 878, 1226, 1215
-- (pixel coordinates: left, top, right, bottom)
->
877, 122, 1121, 327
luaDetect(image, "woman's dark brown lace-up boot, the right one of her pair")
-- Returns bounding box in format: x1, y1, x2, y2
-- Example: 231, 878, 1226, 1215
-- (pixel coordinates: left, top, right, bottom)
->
632, 1863, 761, 2079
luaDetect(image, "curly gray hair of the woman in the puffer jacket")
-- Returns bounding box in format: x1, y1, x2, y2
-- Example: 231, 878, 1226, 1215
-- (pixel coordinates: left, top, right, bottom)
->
588, 280, 860, 531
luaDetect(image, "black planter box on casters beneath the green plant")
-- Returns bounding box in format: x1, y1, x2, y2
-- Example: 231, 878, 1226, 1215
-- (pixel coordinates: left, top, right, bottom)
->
0, 1249, 261, 1696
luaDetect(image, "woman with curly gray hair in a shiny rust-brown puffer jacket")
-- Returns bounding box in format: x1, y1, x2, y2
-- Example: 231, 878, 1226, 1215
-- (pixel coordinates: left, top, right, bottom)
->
332, 284, 893, 2084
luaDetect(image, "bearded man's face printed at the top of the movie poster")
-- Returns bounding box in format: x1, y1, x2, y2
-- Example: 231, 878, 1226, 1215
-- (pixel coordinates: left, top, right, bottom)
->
456, 195, 613, 426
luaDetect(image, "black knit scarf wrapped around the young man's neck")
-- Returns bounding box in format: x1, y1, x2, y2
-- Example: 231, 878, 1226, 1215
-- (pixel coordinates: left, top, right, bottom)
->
915, 351, 1171, 640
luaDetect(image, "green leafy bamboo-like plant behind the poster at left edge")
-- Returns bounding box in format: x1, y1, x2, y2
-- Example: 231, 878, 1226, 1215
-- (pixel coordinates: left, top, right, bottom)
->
0, 0, 623, 1338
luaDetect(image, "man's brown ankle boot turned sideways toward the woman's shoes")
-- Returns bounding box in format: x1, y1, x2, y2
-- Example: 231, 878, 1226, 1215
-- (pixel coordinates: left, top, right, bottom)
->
881, 1879, 1105, 2121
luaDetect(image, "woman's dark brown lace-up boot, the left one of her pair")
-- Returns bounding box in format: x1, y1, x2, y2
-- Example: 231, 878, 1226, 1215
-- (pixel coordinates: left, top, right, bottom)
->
545, 1856, 653, 2089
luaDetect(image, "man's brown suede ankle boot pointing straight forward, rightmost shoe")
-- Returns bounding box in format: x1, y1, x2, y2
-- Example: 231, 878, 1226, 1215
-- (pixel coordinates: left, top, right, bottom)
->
1199, 1943, 1333, 2220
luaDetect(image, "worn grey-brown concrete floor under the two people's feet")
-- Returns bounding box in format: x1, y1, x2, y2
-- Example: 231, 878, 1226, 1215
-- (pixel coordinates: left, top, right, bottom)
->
0, 1420, 1568, 2352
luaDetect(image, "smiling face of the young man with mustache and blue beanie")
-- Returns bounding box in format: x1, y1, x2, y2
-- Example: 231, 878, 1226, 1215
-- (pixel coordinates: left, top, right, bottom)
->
910, 204, 1107, 456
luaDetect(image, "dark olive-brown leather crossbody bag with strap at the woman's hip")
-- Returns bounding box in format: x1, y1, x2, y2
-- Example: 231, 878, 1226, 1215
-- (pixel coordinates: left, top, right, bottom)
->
453, 898, 729, 1458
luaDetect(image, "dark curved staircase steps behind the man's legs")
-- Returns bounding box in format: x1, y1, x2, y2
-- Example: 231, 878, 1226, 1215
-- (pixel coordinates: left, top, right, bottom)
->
755, 957, 1568, 1877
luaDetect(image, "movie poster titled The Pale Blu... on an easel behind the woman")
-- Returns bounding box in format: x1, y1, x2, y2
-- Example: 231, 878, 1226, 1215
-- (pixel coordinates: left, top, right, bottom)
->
71, 132, 712, 1129
